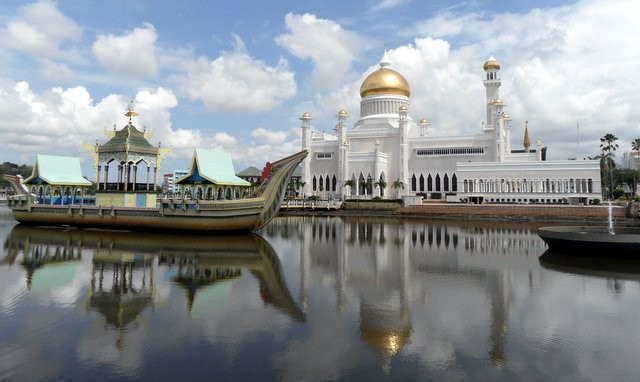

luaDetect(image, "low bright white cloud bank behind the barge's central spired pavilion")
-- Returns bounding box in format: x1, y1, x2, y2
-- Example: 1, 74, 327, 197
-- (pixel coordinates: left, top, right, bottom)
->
0, 79, 177, 163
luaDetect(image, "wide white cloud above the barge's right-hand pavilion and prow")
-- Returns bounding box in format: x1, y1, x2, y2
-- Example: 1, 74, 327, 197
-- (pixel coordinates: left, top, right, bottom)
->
173, 36, 296, 113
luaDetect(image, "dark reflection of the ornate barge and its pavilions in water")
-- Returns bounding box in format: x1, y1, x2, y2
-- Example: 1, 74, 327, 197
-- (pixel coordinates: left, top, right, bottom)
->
3, 225, 306, 349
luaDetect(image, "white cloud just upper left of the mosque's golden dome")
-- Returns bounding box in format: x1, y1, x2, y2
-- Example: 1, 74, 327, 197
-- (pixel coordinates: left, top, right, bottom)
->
275, 13, 364, 90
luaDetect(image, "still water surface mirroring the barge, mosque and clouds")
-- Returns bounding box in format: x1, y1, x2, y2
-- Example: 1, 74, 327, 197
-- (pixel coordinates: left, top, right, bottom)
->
0, 209, 640, 381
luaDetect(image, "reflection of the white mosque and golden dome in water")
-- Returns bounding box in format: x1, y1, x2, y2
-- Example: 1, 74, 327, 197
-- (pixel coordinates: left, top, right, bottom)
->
266, 217, 546, 369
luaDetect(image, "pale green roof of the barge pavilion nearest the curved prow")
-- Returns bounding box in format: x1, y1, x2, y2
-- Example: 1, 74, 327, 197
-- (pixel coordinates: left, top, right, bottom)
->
175, 149, 251, 187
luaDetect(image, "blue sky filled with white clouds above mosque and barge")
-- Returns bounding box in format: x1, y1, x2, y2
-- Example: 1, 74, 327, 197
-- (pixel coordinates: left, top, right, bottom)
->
0, 0, 640, 178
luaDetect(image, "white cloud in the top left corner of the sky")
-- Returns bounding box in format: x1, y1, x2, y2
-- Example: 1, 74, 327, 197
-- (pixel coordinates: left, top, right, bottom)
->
0, 0, 82, 61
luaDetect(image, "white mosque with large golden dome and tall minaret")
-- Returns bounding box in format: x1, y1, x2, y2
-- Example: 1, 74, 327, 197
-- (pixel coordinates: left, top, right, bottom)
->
300, 52, 602, 204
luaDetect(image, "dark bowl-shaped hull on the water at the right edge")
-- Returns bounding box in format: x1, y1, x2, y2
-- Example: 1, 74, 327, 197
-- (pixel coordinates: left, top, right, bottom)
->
538, 226, 640, 256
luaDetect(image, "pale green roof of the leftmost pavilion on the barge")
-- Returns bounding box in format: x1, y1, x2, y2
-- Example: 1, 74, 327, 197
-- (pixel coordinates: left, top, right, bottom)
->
24, 155, 92, 186
